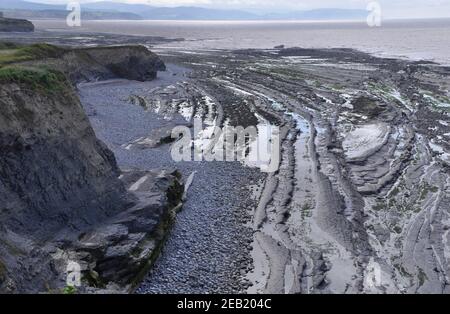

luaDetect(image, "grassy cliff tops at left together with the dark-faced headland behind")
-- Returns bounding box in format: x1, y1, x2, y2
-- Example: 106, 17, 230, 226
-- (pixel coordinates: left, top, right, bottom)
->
0, 42, 165, 91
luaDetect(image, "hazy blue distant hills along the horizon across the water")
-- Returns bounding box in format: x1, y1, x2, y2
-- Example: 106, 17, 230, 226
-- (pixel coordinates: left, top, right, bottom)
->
0, 0, 367, 20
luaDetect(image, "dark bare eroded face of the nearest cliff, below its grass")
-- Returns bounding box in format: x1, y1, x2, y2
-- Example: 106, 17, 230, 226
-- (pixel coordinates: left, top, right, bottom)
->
0, 80, 127, 238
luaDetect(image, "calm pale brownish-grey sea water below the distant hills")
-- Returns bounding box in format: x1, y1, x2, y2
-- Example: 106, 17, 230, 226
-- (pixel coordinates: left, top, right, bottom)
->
33, 19, 450, 65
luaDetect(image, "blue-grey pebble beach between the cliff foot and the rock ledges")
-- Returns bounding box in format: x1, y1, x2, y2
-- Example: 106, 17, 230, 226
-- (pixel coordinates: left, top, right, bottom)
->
79, 64, 264, 293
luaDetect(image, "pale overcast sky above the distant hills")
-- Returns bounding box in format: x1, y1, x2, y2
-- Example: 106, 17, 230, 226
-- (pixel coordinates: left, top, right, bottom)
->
34, 0, 450, 18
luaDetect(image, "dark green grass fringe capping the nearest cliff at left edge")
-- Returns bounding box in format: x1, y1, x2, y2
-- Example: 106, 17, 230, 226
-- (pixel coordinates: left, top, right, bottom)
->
0, 66, 69, 93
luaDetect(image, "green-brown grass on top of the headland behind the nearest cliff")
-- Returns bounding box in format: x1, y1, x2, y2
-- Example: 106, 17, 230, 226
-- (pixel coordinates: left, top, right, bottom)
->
0, 42, 66, 67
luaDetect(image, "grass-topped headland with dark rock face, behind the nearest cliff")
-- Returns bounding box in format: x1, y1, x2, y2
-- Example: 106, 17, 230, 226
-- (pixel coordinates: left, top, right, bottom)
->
0, 43, 165, 83
